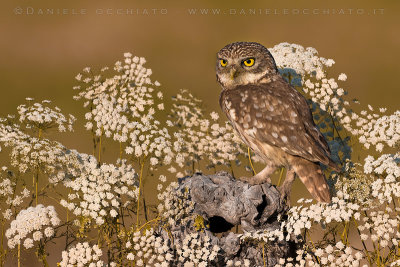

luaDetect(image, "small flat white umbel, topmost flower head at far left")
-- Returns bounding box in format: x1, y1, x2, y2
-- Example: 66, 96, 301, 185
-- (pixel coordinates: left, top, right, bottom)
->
17, 98, 76, 132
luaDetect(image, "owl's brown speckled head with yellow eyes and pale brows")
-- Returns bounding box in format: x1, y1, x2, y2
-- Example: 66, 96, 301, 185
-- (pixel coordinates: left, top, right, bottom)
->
216, 42, 278, 89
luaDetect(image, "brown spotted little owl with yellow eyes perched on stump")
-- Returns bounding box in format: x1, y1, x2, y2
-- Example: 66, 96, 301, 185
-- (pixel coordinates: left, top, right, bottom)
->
216, 42, 339, 202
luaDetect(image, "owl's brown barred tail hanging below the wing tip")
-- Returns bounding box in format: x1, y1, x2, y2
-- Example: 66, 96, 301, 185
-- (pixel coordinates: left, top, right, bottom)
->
292, 159, 331, 203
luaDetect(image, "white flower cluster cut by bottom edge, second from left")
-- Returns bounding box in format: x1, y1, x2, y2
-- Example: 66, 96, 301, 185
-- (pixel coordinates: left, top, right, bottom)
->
126, 229, 174, 267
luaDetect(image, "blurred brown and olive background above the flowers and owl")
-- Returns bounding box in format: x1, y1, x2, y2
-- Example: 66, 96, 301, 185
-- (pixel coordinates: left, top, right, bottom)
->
0, 0, 400, 266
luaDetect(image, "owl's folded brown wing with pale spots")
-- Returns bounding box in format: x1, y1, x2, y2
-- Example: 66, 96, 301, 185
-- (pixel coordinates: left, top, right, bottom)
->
220, 80, 337, 169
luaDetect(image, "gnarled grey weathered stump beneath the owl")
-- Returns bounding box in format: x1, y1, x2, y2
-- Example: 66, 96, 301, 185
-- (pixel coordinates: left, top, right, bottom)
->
162, 172, 295, 266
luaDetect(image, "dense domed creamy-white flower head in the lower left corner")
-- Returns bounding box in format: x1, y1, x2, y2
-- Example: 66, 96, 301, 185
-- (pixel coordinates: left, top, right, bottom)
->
6, 204, 60, 249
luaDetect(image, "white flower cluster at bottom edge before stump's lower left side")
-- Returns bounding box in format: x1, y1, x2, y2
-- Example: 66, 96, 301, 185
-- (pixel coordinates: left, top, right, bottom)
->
176, 232, 220, 267
